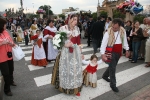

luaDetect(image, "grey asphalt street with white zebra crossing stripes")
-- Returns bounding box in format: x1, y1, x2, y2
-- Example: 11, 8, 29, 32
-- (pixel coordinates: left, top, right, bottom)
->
4, 34, 150, 100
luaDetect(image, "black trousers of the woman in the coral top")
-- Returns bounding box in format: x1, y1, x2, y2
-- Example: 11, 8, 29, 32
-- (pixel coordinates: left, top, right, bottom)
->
0, 60, 14, 93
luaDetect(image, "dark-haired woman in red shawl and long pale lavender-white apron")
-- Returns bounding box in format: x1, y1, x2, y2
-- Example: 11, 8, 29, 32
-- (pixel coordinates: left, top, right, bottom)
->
43, 20, 58, 62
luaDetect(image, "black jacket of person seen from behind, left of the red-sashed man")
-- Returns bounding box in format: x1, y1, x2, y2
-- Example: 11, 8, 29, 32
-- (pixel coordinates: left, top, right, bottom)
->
90, 21, 104, 39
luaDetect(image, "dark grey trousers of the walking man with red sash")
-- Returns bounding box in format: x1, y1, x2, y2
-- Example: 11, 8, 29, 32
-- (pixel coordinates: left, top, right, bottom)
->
103, 53, 120, 87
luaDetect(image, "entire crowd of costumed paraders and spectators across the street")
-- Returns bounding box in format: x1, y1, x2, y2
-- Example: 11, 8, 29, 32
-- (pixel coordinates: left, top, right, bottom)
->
0, 14, 150, 96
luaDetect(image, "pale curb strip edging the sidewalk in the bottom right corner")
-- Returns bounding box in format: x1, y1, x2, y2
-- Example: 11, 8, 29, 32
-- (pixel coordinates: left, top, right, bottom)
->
122, 85, 150, 100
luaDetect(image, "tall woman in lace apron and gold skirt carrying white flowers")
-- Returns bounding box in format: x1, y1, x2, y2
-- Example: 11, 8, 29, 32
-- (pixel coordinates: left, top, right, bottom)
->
51, 14, 83, 96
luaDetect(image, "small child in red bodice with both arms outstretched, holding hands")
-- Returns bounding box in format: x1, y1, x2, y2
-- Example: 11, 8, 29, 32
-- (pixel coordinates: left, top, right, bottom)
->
82, 55, 102, 88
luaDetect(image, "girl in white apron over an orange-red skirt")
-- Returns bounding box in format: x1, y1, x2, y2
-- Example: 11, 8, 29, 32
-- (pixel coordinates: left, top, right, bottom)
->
31, 30, 47, 67
